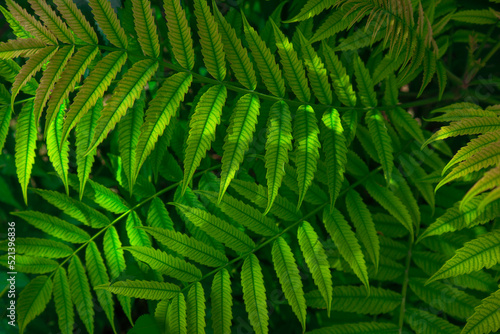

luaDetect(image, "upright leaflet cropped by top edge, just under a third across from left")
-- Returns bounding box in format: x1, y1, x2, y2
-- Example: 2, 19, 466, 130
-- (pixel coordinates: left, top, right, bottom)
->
132, 0, 160, 58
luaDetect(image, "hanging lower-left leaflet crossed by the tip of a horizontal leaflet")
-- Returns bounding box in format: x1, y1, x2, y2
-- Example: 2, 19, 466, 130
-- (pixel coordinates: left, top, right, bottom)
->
85, 241, 116, 332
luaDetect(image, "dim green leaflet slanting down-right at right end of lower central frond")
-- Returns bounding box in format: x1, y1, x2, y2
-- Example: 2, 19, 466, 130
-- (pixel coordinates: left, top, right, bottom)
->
365, 180, 414, 238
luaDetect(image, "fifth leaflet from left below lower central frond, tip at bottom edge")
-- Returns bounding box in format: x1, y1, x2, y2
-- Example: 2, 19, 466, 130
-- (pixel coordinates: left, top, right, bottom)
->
272, 237, 306, 332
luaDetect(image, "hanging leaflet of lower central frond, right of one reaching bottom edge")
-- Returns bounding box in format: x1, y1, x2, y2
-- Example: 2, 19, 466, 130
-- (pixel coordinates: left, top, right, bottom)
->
297, 222, 333, 316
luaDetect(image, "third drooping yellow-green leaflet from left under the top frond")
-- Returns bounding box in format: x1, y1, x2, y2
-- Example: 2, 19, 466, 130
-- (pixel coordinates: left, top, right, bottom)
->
45, 46, 99, 132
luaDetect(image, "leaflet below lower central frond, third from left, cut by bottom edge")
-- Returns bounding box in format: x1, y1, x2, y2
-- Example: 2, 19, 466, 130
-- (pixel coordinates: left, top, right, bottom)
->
210, 268, 233, 334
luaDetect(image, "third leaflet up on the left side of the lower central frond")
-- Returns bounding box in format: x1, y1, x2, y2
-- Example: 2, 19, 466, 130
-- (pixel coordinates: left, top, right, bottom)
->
141, 227, 228, 267
